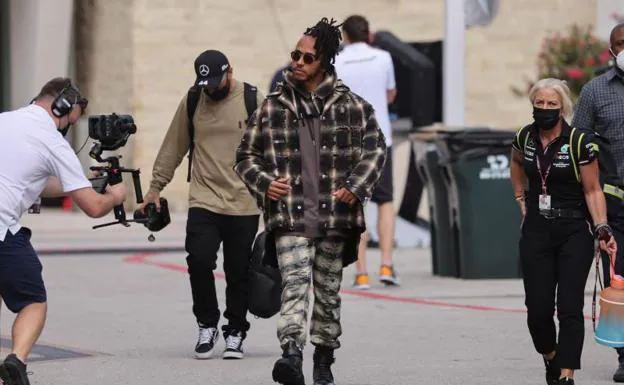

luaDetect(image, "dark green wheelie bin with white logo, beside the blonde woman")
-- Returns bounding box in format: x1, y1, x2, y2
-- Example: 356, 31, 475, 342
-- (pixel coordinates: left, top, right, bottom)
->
437, 129, 521, 279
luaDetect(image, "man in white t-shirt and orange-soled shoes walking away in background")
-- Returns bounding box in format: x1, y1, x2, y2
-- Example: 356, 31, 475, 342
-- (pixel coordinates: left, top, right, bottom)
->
334, 15, 399, 289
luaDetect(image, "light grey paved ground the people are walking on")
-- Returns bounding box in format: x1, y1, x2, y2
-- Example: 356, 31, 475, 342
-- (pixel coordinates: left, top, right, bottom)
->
0, 210, 616, 385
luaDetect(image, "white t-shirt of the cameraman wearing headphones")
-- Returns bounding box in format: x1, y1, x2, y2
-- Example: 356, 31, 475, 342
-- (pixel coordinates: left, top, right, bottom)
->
0, 104, 91, 241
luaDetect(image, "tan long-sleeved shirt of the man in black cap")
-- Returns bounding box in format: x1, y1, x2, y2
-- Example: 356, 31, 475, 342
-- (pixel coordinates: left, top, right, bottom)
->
150, 79, 264, 215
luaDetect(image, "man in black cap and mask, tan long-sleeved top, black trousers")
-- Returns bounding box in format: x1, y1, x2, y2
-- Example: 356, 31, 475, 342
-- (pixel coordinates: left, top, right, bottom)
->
140, 50, 264, 359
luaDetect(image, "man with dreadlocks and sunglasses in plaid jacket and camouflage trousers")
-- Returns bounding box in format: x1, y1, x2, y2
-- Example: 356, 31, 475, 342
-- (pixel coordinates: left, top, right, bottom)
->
234, 18, 386, 385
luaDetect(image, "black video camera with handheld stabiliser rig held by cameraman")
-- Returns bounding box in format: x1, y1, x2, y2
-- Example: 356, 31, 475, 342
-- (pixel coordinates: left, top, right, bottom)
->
89, 113, 171, 237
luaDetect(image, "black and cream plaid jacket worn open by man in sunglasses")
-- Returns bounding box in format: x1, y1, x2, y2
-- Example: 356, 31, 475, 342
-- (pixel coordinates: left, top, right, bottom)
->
234, 74, 386, 232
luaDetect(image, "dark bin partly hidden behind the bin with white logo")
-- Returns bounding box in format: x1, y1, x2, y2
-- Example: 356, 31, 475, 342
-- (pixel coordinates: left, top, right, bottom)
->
416, 143, 458, 277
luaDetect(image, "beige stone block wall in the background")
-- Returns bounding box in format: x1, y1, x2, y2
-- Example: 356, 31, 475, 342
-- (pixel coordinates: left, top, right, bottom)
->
78, 0, 596, 210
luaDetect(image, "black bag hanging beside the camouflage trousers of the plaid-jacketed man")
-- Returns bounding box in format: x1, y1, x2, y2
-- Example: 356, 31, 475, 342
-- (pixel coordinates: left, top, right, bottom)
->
248, 231, 282, 319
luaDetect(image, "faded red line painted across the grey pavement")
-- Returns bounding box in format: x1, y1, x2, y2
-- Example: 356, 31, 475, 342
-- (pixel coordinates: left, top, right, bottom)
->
124, 252, 598, 320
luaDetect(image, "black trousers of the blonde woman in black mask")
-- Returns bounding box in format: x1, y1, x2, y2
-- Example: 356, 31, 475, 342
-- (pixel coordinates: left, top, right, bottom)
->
519, 212, 594, 369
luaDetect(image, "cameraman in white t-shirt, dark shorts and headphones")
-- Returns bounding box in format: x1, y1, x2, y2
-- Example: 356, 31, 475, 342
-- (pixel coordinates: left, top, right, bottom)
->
0, 78, 126, 385
